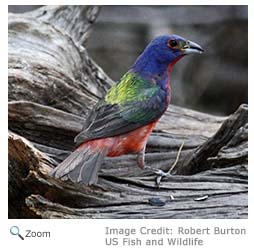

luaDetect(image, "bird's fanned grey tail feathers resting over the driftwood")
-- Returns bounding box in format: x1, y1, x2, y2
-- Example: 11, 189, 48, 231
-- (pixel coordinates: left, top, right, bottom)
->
50, 145, 107, 185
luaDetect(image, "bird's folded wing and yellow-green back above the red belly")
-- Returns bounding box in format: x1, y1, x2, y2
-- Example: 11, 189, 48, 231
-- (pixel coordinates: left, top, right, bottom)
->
75, 72, 167, 145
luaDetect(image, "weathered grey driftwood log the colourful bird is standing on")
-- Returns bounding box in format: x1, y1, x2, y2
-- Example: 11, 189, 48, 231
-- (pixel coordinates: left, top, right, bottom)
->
9, 6, 248, 218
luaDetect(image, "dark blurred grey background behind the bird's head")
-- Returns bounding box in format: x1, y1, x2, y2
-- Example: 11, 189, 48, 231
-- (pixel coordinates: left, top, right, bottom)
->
9, 5, 248, 115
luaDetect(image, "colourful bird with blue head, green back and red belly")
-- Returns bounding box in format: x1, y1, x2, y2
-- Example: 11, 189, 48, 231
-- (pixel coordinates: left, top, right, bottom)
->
50, 34, 204, 185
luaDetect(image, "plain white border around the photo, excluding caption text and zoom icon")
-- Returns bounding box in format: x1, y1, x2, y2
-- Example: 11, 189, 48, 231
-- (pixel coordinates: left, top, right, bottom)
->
0, 0, 254, 250
